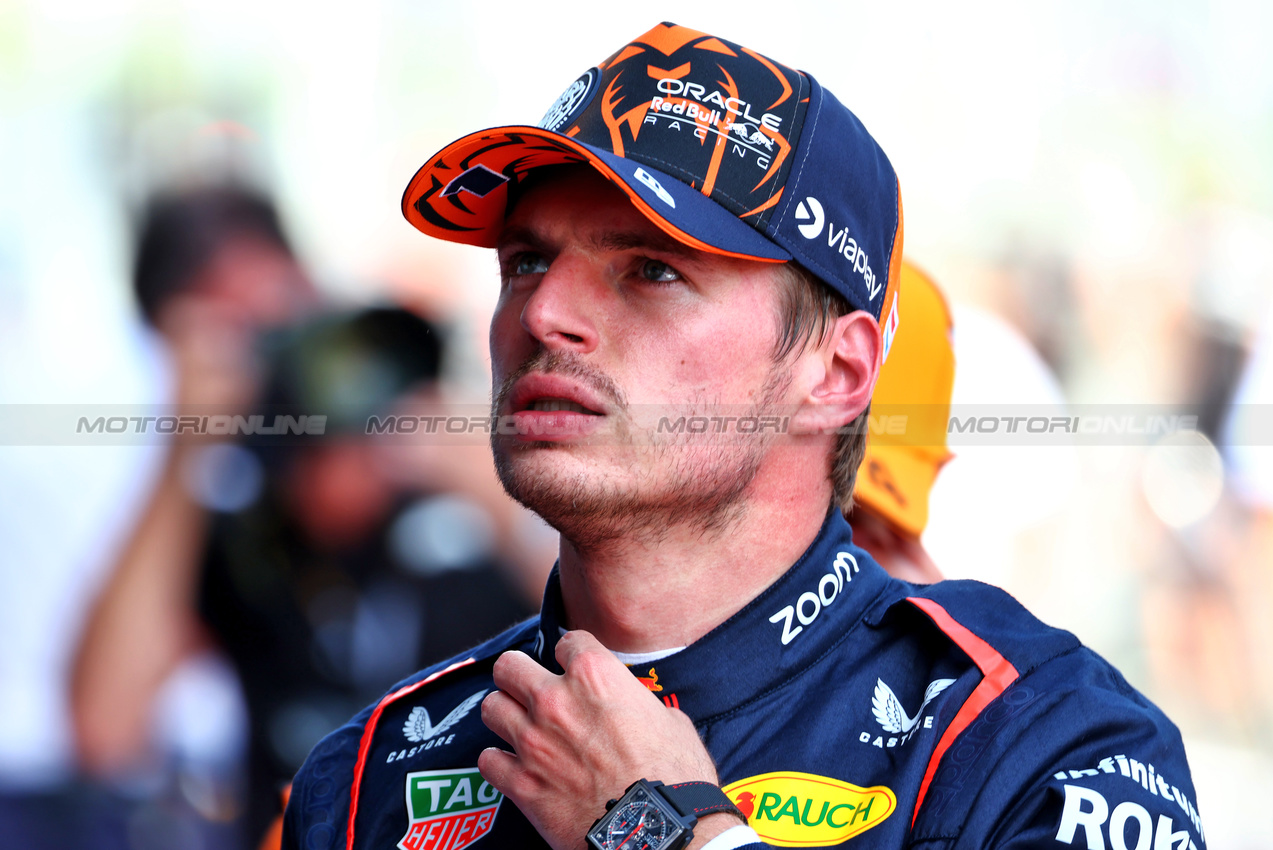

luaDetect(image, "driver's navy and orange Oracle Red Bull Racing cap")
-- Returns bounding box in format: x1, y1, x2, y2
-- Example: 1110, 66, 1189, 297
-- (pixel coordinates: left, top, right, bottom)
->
402, 23, 903, 330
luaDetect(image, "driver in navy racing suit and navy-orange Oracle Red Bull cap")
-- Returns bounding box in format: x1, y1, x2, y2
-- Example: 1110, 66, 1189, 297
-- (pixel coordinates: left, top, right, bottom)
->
284, 24, 1204, 850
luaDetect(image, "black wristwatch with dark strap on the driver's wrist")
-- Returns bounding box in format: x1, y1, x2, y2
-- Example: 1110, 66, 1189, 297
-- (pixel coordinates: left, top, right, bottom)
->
588, 779, 747, 850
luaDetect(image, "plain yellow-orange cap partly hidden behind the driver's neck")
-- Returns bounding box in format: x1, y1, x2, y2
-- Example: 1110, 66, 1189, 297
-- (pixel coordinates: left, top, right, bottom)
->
853, 261, 955, 537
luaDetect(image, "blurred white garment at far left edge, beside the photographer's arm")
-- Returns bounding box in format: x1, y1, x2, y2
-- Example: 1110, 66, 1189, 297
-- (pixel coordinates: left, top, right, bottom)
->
0, 318, 171, 794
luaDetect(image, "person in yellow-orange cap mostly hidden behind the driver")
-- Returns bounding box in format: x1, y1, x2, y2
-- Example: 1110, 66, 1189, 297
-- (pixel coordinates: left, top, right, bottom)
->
848, 261, 955, 584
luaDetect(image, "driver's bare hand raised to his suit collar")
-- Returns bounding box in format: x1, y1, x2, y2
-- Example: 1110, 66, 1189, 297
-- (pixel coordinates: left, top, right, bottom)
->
477, 631, 738, 850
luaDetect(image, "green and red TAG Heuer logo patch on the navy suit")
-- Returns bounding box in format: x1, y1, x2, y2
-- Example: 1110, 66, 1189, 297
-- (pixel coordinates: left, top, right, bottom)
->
398, 767, 504, 850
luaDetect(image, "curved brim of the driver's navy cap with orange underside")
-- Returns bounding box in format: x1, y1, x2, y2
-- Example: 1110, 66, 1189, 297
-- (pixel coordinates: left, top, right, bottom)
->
402, 126, 792, 262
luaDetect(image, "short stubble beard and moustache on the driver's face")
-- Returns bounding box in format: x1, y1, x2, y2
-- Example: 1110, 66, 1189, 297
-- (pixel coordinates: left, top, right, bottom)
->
491, 351, 791, 551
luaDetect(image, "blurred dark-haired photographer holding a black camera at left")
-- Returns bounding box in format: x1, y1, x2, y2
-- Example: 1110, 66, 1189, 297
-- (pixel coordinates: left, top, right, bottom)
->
71, 188, 547, 847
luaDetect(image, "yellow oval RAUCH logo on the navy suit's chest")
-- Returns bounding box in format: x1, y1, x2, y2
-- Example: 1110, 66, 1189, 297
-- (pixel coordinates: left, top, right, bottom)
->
724, 771, 897, 847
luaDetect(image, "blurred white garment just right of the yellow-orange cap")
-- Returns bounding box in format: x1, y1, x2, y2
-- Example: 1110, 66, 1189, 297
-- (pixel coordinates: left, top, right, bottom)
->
921, 304, 1078, 593
